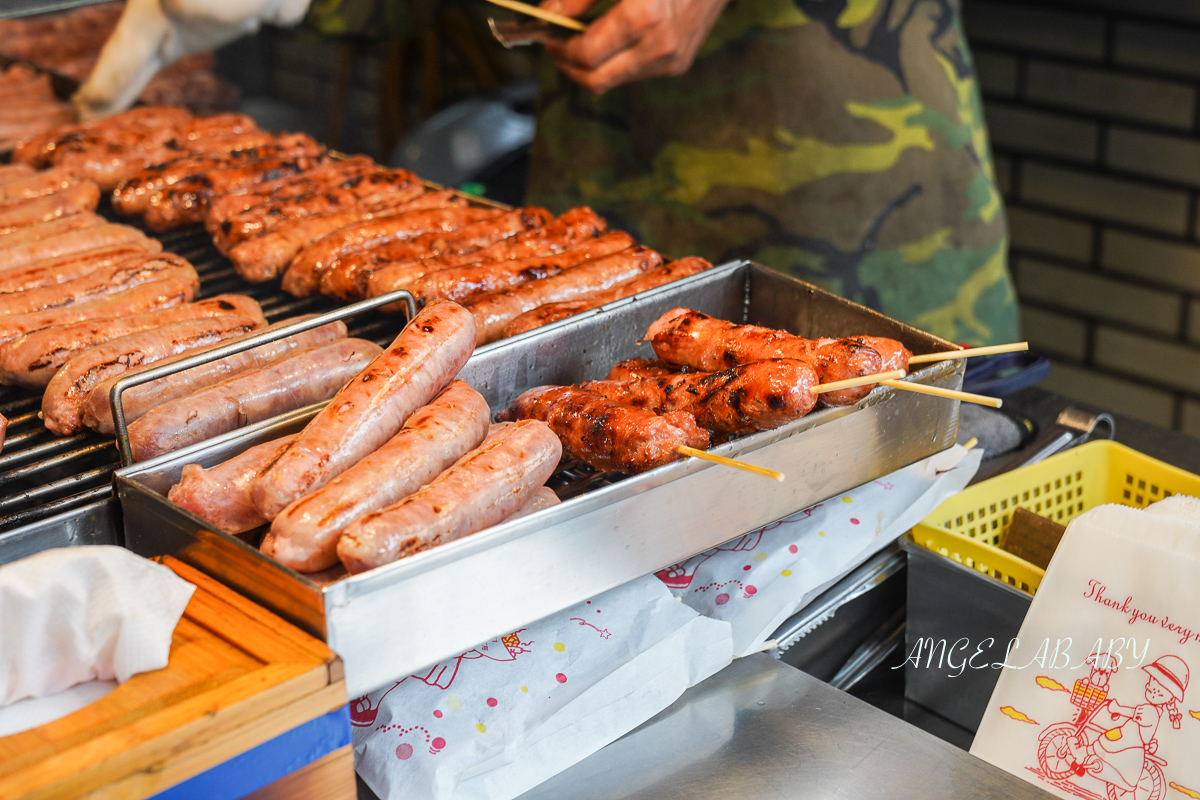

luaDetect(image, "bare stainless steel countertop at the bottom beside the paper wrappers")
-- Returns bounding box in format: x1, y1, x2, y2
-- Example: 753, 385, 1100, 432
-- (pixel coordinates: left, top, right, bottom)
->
520, 655, 1052, 800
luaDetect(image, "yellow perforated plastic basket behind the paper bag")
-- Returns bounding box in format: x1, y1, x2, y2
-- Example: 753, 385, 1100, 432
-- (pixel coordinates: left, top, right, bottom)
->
912, 441, 1200, 595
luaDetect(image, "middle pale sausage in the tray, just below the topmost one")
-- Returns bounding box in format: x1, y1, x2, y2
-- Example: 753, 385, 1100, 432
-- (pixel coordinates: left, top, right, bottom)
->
263, 380, 491, 572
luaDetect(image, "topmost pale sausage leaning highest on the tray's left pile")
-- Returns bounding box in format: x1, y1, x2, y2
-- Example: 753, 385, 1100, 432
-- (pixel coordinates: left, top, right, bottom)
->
253, 303, 475, 519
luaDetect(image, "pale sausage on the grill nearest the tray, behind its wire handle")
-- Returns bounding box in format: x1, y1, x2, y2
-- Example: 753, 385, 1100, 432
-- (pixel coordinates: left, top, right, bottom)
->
130, 339, 383, 461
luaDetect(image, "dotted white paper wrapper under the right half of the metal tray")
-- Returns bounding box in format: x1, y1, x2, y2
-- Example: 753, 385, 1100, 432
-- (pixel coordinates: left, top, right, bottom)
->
658, 445, 983, 657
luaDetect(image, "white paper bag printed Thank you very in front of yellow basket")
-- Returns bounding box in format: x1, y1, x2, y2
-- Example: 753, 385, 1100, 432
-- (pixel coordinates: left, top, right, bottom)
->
971, 500, 1200, 800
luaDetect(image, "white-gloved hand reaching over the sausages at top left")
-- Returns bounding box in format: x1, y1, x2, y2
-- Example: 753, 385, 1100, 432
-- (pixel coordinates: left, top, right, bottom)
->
73, 0, 308, 119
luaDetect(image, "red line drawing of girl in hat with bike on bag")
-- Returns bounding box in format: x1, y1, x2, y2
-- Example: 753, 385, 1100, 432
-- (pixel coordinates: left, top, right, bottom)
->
1022, 652, 1189, 800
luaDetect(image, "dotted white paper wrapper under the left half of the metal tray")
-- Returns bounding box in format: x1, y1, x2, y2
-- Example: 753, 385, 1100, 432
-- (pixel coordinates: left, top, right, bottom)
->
350, 576, 732, 800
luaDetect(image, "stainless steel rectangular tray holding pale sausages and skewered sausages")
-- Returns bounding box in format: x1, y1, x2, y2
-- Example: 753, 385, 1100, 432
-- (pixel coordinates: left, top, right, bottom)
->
115, 263, 962, 696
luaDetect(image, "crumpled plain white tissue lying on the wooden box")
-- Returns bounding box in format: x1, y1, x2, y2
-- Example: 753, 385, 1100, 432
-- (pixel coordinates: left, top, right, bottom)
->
0, 546, 196, 733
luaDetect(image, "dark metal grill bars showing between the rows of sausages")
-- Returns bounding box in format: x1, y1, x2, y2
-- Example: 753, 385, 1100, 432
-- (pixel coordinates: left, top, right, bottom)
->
0, 219, 404, 531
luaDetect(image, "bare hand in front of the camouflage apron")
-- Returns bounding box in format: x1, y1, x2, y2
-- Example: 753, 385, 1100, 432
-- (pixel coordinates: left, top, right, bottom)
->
541, 0, 728, 95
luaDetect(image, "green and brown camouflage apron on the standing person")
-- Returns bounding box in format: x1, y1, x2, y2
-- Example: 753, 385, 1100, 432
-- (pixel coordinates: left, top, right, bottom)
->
528, 0, 1018, 344
